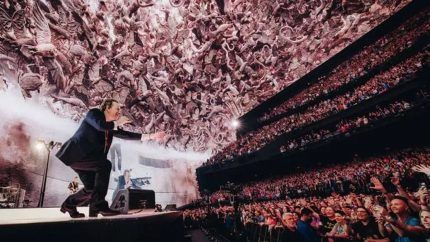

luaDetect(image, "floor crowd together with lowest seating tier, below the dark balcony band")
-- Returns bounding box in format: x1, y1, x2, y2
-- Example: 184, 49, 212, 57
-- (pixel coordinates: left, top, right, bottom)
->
184, 148, 430, 242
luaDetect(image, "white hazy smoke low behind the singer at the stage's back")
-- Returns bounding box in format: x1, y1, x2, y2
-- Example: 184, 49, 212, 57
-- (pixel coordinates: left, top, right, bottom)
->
0, 86, 210, 207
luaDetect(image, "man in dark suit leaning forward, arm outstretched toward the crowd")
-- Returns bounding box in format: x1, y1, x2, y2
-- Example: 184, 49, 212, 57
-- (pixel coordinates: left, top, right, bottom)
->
56, 99, 165, 218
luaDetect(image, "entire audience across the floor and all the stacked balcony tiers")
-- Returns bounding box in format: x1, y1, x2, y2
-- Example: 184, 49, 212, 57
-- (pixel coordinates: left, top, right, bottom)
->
183, 2, 430, 242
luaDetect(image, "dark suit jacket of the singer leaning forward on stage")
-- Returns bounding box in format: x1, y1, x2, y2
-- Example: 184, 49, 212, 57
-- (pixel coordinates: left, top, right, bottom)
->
56, 108, 142, 165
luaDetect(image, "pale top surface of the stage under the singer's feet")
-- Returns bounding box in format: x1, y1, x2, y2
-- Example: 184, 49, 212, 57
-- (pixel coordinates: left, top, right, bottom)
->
0, 207, 173, 225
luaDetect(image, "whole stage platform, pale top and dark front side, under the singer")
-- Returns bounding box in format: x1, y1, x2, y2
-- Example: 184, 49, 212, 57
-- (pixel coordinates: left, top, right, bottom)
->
0, 207, 184, 242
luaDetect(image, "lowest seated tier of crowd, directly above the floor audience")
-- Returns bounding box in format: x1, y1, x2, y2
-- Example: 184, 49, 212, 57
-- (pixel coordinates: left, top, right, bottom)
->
239, 151, 430, 199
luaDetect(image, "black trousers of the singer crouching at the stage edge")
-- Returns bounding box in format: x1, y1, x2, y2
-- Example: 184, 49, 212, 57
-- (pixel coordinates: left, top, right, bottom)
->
63, 160, 112, 209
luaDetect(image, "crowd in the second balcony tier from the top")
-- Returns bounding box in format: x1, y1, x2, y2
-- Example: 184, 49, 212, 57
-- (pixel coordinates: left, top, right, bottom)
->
204, 42, 430, 165
